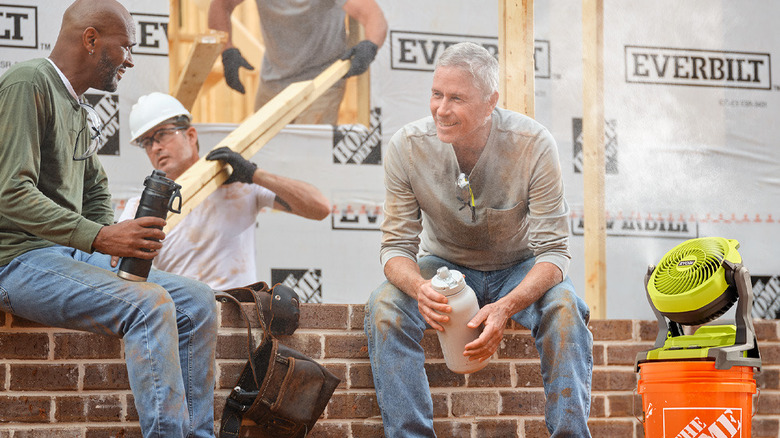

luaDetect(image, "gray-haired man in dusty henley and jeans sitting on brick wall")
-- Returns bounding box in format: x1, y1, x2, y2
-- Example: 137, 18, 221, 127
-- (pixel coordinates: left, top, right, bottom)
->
365, 43, 593, 438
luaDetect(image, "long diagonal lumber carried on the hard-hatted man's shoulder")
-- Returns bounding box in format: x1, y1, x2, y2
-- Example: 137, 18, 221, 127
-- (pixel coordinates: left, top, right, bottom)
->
165, 60, 350, 232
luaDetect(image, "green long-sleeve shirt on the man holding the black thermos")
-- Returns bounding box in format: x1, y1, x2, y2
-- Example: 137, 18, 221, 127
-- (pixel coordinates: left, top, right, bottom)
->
0, 59, 114, 266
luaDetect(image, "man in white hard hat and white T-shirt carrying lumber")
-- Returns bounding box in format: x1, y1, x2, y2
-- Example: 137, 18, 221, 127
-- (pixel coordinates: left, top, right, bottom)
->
119, 92, 330, 290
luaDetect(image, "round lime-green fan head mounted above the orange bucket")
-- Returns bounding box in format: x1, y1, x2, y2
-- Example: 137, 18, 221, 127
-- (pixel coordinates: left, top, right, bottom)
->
647, 237, 742, 325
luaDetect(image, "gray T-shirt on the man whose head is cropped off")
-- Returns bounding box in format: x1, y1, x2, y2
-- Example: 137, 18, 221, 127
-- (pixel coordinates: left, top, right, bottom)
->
256, 0, 347, 84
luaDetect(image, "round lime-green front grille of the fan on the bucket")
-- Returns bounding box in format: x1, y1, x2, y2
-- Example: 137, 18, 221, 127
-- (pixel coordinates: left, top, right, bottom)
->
653, 239, 729, 295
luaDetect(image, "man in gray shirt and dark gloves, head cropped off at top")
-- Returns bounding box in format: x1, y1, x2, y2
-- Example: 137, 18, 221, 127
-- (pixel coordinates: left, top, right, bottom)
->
209, 0, 387, 125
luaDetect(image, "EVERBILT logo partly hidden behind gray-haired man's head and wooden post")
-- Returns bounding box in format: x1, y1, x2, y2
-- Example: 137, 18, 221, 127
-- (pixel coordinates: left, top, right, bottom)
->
390, 30, 550, 78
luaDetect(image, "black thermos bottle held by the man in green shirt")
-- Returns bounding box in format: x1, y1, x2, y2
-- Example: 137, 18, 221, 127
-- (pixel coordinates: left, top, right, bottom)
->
117, 170, 181, 281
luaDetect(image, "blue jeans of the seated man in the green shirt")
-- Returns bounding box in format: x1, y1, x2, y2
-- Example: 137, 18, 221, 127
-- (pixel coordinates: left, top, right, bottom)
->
0, 246, 217, 438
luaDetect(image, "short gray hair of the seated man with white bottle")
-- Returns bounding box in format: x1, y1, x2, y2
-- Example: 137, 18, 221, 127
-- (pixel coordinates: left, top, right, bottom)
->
435, 42, 498, 100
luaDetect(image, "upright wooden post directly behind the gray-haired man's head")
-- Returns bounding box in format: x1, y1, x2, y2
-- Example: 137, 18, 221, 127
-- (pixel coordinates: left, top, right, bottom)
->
498, 0, 535, 117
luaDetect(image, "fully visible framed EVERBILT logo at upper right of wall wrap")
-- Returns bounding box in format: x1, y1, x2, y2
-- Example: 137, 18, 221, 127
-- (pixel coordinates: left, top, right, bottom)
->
625, 46, 772, 90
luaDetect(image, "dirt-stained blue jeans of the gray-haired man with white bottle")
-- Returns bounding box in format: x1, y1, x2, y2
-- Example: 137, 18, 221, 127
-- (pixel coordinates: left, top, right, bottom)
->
364, 256, 593, 438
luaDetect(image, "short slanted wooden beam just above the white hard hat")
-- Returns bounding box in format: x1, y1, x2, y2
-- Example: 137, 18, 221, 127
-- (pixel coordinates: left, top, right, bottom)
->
171, 31, 227, 111
